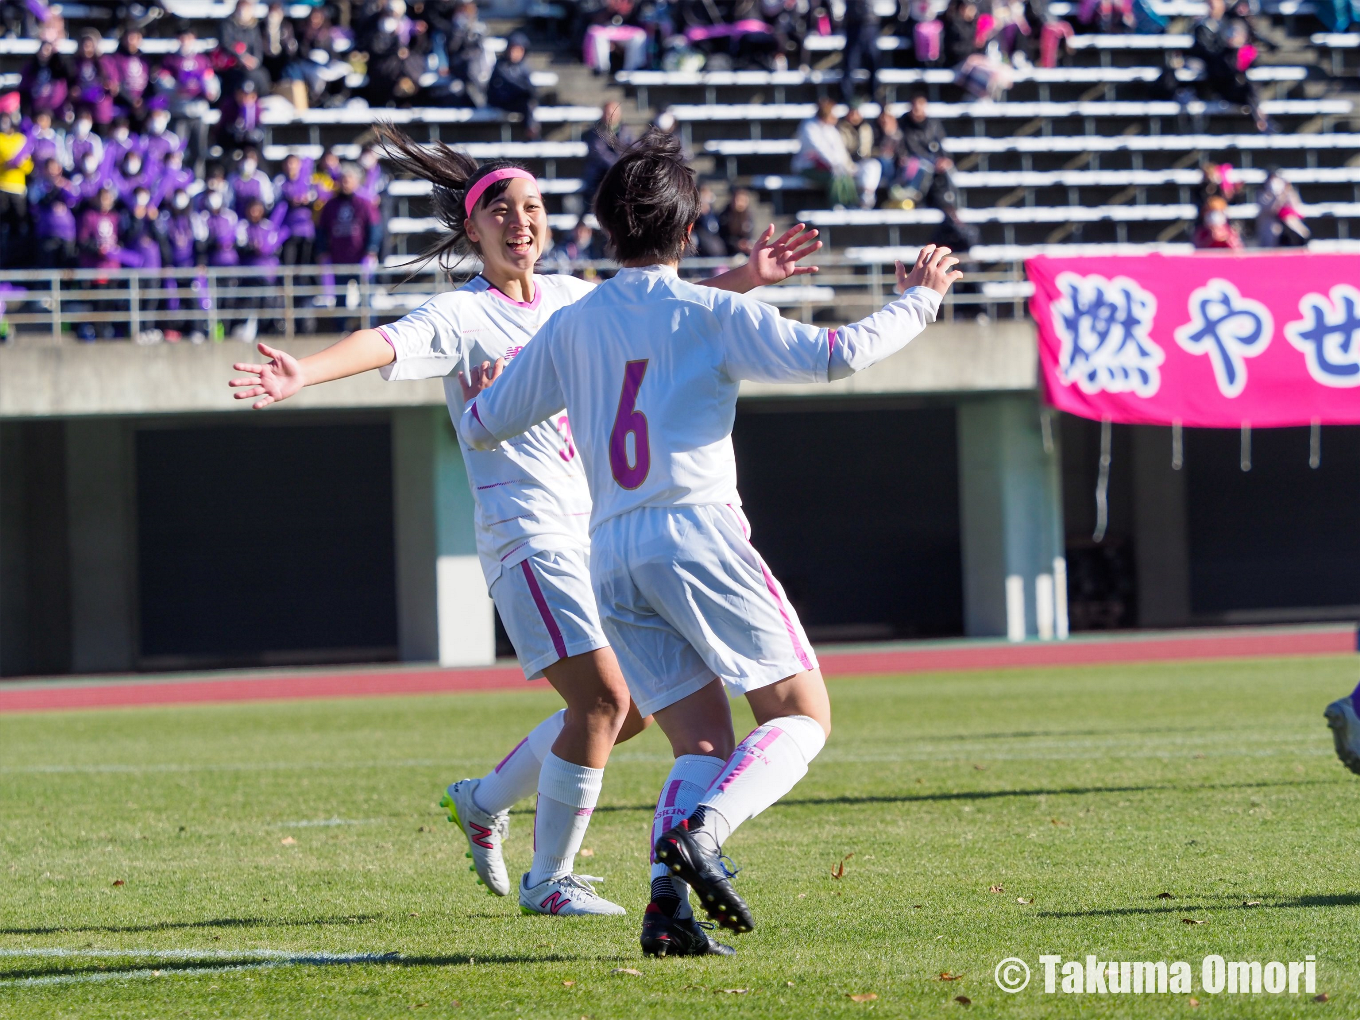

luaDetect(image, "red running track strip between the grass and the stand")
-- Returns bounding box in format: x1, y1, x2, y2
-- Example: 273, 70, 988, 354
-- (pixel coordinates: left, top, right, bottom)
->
0, 624, 1357, 713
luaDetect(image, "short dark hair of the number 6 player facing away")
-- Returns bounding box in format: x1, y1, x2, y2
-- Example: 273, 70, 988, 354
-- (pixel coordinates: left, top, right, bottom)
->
596, 129, 699, 265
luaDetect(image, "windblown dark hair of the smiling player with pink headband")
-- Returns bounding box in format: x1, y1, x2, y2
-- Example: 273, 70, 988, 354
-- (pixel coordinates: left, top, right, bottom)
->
374, 124, 538, 269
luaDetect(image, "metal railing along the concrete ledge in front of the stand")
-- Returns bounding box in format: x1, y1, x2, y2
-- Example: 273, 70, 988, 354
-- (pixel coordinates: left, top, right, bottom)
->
0, 256, 1030, 344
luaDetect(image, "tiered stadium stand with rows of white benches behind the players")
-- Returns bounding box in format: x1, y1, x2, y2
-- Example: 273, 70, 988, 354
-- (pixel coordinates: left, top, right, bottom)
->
0, 0, 1360, 340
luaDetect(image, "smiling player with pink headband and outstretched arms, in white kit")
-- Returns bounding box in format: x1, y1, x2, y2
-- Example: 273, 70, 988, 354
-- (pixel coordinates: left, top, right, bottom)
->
231, 123, 821, 924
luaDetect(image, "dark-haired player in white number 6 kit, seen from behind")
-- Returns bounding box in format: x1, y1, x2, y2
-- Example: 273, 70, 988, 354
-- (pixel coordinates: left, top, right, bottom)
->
460, 135, 960, 955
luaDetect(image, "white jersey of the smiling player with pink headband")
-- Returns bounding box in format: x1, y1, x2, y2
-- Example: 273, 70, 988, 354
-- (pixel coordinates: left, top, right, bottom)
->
378, 276, 594, 588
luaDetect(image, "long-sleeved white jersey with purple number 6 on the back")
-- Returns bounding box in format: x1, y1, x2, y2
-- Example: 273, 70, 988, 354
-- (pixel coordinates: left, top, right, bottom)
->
461, 267, 940, 529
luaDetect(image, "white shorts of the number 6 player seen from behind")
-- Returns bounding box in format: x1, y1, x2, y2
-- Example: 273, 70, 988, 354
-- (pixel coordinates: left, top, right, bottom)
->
590, 506, 817, 715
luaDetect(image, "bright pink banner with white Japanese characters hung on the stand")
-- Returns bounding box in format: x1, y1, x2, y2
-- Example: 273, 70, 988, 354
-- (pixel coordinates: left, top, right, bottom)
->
1025, 252, 1360, 428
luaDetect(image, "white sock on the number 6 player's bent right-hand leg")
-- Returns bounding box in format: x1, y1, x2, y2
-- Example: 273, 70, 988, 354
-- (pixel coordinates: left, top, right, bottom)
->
690, 715, 827, 849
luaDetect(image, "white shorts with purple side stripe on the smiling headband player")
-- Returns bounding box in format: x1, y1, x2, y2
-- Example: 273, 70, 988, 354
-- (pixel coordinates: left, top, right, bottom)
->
491, 549, 609, 680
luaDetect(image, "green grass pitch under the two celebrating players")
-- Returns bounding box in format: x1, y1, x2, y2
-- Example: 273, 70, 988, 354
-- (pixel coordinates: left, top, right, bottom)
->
0, 656, 1360, 1020
